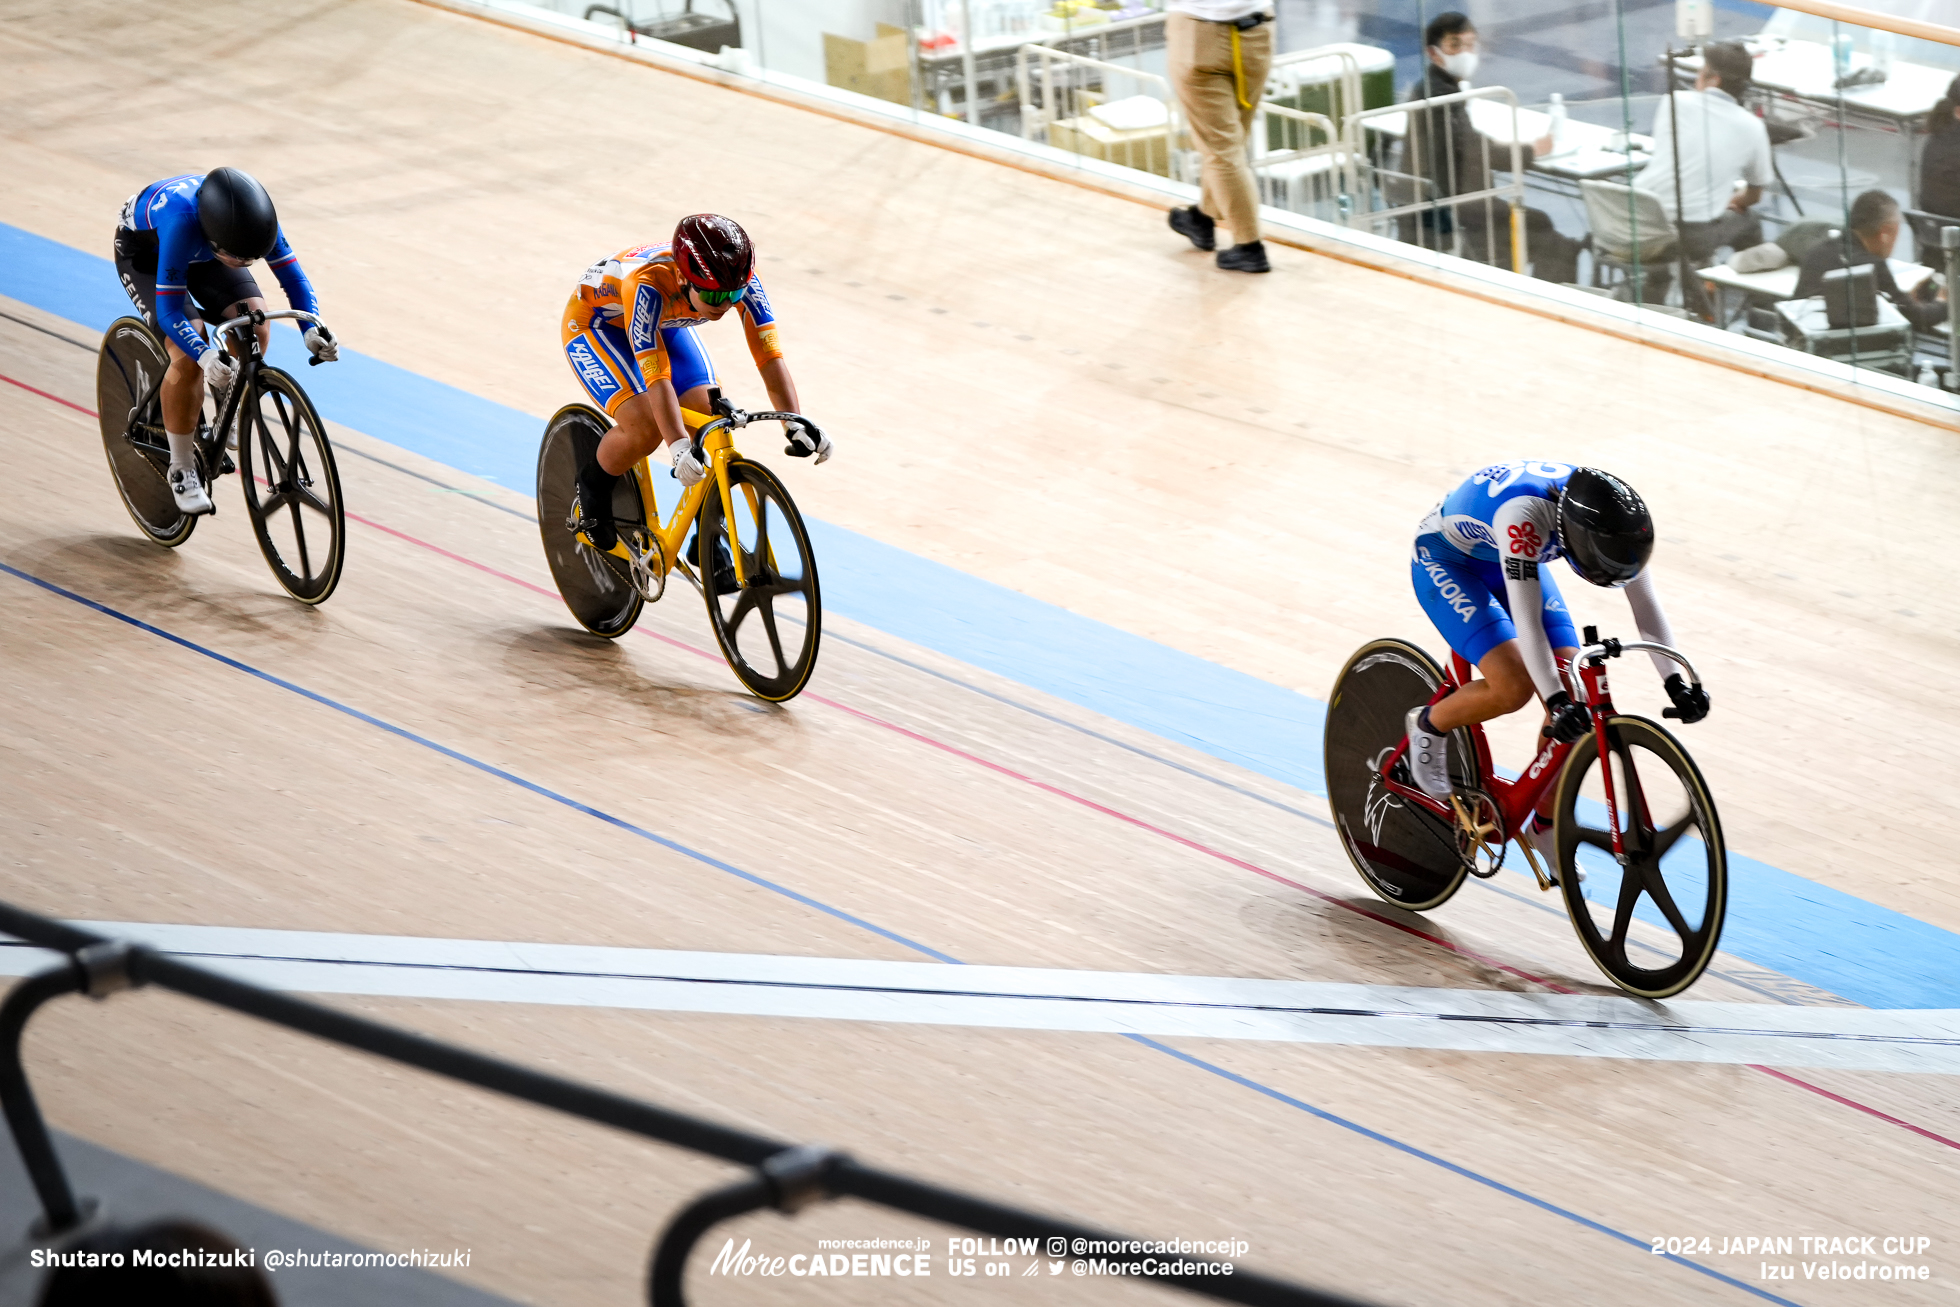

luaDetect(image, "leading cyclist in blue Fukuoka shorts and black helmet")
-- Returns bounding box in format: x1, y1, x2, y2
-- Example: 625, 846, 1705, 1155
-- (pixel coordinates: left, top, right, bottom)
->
1407, 462, 1709, 854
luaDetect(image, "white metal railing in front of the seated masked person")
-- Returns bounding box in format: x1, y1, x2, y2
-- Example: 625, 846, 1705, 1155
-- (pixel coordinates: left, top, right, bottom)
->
1343, 86, 1531, 272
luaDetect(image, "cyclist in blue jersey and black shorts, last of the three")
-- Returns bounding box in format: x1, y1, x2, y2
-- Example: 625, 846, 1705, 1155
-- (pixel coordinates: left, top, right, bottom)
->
116, 169, 339, 513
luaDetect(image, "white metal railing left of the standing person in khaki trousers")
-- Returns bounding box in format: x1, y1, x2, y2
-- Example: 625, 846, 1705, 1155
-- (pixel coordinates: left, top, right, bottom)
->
1013, 45, 1194, 180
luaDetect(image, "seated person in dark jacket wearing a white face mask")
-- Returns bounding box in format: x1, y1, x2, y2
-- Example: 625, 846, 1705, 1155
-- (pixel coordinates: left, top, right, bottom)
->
1399, 12, 1584, 284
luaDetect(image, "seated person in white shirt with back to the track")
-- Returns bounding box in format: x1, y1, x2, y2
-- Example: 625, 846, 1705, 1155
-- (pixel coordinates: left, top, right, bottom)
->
1633, 41, 1776, 317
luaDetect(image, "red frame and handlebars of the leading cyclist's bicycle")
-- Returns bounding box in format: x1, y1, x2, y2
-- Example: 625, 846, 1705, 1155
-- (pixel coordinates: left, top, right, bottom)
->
1380, 627, 1701, 890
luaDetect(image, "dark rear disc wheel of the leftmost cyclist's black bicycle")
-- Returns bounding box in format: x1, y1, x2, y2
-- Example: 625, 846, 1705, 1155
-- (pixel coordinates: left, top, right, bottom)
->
96, 317, 198, 549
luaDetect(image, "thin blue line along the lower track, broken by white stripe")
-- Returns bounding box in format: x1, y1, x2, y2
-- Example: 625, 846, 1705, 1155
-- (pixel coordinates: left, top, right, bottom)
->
0, 562, 1799, 1307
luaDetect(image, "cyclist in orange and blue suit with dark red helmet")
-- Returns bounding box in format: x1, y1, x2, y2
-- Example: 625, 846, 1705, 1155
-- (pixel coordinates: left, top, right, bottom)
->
561, 214, 831, 549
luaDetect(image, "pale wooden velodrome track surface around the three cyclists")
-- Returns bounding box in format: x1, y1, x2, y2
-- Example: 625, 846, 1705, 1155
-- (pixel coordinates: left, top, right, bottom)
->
0, 0, 1960, 1303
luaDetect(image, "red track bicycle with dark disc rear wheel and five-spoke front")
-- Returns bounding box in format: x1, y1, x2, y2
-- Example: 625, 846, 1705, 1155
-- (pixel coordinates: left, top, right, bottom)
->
1325, 627, 1729, 997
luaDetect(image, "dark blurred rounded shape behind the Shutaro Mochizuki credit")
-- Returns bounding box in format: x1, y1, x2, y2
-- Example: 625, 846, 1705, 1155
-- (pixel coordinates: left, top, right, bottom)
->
39, 1221, 278, 1307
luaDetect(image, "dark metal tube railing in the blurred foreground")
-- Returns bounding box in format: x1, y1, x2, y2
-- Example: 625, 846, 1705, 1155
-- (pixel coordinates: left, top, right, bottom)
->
0, 903, 1387, 1307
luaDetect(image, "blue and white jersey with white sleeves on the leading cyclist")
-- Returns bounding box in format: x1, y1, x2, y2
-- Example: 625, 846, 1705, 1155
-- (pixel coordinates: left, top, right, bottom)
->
1417, 460, 1678, 698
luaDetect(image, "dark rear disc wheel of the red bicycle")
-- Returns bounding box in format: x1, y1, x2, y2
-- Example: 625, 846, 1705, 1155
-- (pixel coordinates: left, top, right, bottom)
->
1323, 639, 1474, 911
